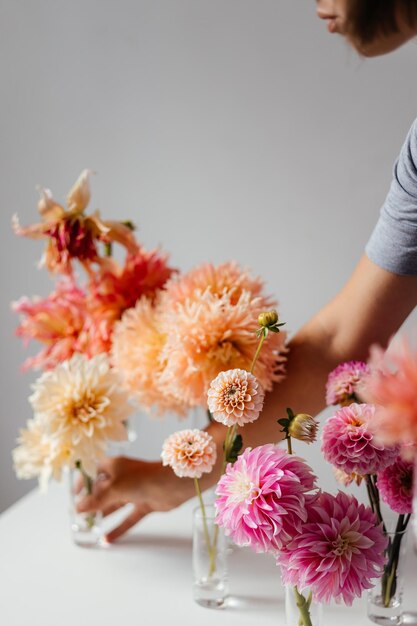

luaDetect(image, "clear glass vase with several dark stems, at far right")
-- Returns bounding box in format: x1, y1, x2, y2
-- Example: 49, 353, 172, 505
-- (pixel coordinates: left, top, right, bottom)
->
368, 529, 407, 625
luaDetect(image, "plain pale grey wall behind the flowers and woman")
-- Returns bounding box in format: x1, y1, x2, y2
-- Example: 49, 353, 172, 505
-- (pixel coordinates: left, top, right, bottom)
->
0, 0, 417, 510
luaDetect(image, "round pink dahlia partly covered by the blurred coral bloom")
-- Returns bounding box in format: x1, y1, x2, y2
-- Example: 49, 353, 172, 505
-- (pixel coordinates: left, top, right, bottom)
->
321, 403, 398, 476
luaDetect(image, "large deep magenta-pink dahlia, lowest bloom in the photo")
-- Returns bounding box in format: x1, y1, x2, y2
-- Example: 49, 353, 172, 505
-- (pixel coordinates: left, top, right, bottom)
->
277, 491, 387, 605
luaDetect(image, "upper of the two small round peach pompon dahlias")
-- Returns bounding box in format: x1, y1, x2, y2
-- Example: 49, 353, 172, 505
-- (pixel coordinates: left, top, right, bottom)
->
207, 369, 265, 426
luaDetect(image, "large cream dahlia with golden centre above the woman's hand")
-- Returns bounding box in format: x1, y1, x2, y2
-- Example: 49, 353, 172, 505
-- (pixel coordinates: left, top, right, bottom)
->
29, 354, 132, 477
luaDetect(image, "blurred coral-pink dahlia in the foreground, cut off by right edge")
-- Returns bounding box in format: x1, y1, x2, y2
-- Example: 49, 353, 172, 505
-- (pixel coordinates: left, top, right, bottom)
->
366, 338, 417, 445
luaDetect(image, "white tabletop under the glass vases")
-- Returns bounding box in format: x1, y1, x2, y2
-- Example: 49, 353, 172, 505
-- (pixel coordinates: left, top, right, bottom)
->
0, 485, 417, 626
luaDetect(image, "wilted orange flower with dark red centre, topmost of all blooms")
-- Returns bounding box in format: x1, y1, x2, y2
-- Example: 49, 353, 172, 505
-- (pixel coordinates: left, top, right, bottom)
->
13, 170, 138, 274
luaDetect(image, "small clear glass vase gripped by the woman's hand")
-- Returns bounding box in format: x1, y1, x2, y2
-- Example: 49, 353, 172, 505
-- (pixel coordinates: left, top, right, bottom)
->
69, 467, 103, 547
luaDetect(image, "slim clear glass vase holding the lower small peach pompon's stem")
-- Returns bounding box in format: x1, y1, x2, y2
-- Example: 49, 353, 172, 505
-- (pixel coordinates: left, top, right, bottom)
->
193, 504, 228, 609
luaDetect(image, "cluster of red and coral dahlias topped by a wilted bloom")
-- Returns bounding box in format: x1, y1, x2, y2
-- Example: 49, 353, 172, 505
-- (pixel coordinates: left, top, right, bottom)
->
13, 170, 174, 370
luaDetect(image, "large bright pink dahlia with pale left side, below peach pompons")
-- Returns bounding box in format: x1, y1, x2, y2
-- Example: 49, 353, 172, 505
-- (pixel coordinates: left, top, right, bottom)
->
215, 444, 315, 552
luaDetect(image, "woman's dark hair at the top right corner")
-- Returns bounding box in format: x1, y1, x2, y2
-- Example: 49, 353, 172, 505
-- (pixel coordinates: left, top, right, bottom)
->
347, 0, 417, 44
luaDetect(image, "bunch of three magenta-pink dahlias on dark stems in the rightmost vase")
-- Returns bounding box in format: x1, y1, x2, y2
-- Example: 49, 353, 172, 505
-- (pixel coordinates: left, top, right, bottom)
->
322, 361, 413, 608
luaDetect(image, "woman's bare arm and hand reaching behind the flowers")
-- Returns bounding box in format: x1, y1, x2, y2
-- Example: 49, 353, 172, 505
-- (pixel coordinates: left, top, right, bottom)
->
76, 255, 417, 541
